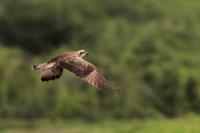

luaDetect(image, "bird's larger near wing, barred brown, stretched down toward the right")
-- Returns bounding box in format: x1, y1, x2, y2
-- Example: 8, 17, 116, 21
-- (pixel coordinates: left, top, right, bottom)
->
61, 58, 112, 91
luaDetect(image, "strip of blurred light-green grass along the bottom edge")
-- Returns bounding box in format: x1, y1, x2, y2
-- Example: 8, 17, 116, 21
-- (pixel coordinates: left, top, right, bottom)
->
0, 116, 200, 133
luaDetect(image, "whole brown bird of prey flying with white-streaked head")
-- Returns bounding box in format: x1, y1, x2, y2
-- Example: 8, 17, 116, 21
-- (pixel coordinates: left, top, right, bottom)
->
32, 50, 112, 91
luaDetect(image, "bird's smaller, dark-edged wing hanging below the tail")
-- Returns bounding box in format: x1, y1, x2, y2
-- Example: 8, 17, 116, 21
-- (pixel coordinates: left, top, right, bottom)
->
41, 63, 63, 81
